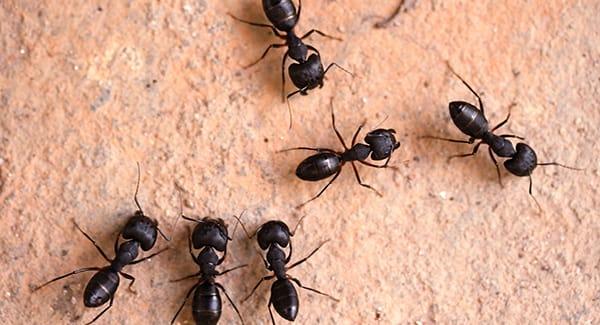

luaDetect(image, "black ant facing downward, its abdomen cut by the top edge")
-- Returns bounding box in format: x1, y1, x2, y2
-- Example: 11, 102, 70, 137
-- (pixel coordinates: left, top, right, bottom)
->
229, 0, 352, 128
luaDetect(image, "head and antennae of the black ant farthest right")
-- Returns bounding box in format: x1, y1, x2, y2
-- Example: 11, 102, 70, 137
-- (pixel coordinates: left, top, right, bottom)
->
504, 142, 581, 211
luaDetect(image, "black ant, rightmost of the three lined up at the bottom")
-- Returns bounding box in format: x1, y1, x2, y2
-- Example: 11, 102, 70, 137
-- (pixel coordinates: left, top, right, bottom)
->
236, 216, 339, 325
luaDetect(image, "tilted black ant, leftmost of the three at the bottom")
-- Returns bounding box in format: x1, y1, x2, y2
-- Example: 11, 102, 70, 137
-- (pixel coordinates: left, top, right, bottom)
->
33, 163, 171, 324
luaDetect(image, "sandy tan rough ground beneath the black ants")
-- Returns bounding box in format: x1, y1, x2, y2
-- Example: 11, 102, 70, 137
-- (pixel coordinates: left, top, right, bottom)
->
0, 0, 600, 324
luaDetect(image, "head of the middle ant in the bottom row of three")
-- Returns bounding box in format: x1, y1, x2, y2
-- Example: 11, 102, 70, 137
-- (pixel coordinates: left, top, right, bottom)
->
192, 217, 230, 252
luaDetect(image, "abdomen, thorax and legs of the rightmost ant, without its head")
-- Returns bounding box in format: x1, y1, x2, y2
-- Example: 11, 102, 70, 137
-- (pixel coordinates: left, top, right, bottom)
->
421, 65, 525, 185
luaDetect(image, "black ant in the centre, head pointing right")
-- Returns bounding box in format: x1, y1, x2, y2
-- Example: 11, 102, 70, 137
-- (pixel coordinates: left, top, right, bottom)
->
279, 99, 400, 208
